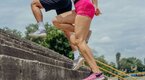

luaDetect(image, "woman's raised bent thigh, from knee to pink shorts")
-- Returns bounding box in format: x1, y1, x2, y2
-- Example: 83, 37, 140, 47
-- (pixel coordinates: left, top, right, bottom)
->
55, 10, 76, 24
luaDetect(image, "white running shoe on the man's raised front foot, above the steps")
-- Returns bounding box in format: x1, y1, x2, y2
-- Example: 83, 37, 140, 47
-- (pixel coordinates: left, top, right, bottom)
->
29, 29, 46, 38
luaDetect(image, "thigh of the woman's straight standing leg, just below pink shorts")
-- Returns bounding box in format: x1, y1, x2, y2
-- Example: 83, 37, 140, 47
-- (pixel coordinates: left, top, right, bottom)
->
75, 15, 92, 41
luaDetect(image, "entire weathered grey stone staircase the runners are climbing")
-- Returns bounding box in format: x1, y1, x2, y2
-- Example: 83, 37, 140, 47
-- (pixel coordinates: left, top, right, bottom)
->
0, 29, 90, 80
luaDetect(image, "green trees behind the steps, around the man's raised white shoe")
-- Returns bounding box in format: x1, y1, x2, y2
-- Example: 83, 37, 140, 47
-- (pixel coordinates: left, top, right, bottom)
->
25, 23, 73, 59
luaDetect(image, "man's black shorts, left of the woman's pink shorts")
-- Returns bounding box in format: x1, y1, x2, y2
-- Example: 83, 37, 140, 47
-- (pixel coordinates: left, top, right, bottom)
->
40, 0, 72, 15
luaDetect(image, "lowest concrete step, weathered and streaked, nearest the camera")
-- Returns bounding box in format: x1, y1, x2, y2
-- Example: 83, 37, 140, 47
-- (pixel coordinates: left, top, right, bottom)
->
0, 55, 89, 80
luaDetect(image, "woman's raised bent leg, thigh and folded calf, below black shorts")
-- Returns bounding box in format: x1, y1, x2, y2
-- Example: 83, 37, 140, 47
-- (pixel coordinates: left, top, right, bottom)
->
52, 10, 76, 32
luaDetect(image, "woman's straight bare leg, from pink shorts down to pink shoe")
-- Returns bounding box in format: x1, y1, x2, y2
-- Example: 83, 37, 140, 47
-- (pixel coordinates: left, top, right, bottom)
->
71, 15, 100, 73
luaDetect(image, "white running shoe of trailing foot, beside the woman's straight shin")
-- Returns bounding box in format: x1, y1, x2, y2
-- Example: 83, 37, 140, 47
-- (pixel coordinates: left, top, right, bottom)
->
72, 57, 85, 70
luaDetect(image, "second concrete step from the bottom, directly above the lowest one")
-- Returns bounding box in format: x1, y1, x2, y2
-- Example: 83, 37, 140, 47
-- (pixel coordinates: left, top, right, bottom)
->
0, 44, 72, 69
